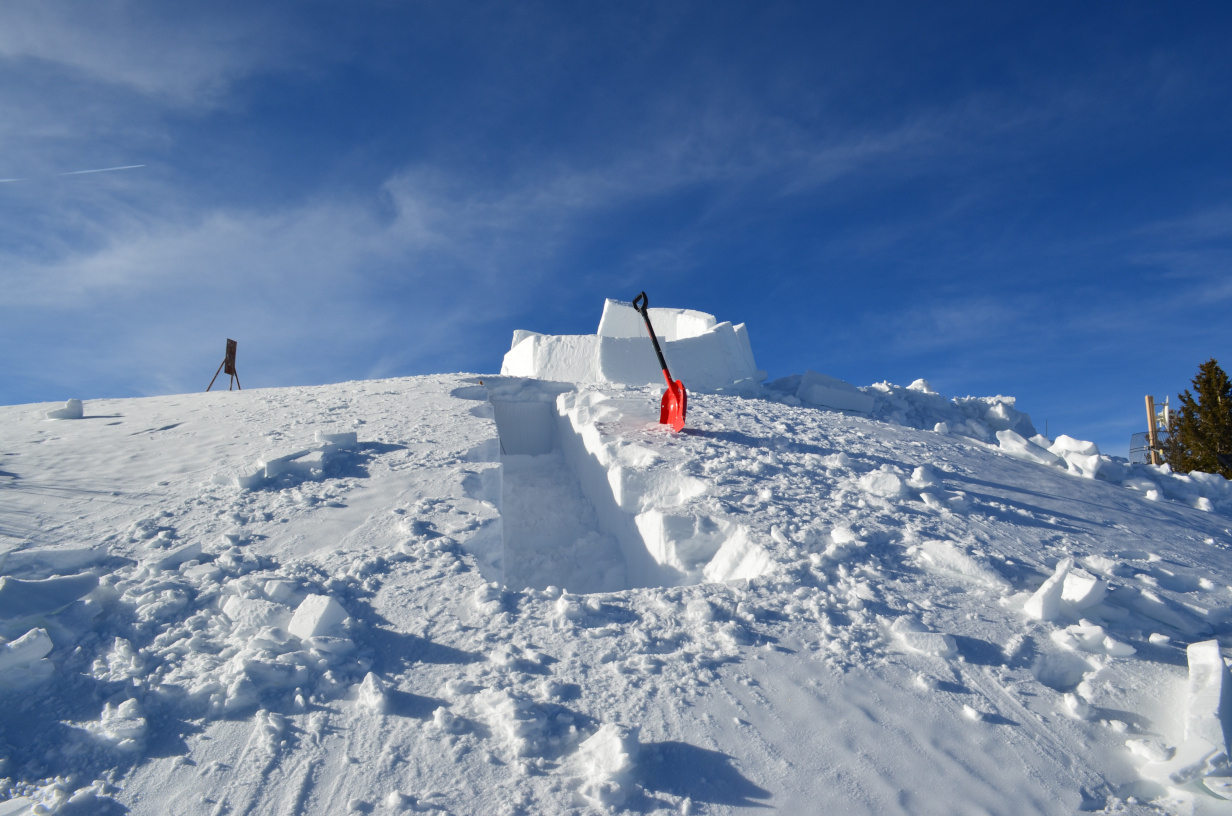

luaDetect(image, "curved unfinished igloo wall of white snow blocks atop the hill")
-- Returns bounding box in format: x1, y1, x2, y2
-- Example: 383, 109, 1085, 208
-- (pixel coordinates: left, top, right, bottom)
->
500, 300, 766, 391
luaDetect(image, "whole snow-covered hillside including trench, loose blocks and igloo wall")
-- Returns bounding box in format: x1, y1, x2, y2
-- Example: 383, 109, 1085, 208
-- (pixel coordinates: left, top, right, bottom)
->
0, 301, 1232, 816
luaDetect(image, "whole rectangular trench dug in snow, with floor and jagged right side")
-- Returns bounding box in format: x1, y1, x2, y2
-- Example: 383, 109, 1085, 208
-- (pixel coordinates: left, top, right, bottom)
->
490, 385, 770, 593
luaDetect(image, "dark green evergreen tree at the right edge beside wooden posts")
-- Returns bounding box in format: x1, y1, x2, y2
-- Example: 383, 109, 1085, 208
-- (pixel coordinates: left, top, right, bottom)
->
1163, 359, 1232, 478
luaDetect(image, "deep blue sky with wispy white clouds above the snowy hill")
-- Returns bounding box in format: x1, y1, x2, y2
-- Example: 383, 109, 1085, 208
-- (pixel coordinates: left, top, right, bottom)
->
0, 0, 1232, 454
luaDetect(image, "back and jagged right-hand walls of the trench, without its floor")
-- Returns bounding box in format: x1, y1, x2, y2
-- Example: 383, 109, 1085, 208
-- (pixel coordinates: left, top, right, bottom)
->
492, 391, 774, 588
